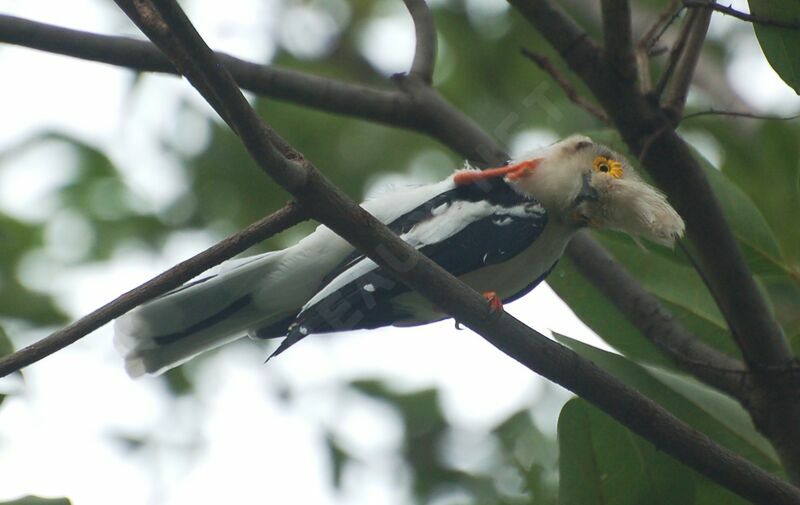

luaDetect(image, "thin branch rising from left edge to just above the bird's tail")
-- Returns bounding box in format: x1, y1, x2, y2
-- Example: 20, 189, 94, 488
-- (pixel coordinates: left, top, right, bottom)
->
0, 203, 307, 377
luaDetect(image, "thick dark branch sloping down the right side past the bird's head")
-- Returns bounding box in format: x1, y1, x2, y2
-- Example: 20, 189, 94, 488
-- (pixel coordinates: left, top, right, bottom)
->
511, 0, 800, 481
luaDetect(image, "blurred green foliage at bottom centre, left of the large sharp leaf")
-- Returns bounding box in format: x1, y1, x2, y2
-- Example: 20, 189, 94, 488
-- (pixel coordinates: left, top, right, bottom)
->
346, 380, 557, 505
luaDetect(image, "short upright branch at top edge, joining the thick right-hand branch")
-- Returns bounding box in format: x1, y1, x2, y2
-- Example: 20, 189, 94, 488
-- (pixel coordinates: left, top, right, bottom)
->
600, 0, 636, 81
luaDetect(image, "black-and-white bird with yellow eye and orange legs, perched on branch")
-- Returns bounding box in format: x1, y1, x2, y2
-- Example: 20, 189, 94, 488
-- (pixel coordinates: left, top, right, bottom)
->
114, 135, 684, 377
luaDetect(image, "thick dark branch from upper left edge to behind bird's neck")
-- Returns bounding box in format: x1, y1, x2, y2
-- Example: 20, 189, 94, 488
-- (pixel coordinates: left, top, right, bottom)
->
0, 16, 752, 398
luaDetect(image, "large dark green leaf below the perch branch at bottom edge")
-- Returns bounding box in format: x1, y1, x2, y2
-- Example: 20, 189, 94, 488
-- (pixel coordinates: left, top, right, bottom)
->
558, 398, 695, 505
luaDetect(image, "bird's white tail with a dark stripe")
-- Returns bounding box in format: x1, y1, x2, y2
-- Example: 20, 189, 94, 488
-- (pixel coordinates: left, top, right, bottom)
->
114, 251, 292, 377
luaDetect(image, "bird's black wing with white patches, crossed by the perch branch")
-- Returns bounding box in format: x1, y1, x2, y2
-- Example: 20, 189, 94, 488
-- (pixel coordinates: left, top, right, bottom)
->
266, 179, 547, 356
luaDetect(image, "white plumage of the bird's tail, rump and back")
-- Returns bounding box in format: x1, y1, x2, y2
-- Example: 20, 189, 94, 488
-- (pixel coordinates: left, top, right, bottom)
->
114, 173, 454, 377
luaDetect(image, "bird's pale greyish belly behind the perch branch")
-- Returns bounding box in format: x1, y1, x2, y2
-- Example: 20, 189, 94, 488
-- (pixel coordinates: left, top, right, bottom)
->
391, 225, 574, 326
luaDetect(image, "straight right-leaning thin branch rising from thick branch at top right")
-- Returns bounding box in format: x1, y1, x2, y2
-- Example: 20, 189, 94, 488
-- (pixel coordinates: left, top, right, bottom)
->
663, 1, 712, 114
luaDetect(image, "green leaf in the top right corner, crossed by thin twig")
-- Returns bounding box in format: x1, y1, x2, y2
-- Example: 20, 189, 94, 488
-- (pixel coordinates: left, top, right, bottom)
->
748, 0, 800, 94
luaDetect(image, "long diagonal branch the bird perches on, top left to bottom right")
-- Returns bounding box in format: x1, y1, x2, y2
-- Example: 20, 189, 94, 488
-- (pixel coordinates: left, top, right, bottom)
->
103, 0, 800, 505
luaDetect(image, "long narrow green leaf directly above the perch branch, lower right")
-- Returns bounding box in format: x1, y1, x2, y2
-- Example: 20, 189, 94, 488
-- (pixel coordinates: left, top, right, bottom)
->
557, 335, 781, 473
